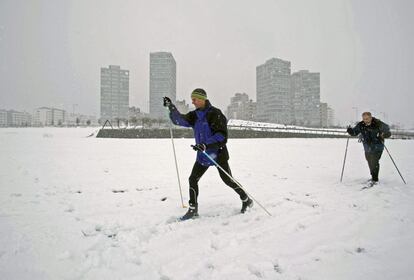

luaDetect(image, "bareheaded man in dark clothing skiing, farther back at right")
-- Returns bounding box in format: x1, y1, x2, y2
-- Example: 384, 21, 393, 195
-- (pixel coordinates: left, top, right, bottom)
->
347, 112, 391, 186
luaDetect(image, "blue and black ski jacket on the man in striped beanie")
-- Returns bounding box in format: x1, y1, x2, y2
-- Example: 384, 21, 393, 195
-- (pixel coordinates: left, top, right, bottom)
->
170, 100, 229, 166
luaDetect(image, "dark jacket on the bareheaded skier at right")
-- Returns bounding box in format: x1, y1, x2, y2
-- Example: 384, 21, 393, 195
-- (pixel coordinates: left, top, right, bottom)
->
349, 118, 391, 153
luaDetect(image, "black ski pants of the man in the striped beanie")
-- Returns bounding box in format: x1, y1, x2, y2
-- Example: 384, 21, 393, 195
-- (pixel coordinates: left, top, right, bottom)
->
189, 160, 247, 205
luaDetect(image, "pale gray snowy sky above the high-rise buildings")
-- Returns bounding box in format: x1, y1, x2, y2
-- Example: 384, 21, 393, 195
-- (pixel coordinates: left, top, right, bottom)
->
0, 0, 414, 127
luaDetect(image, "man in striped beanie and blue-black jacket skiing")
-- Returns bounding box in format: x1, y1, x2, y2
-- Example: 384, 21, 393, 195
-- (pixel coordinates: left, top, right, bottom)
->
164, 88, 253, 220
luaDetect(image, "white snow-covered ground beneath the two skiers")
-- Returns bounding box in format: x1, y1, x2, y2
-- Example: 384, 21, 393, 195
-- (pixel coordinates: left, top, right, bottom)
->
0, 128, 414, 280
